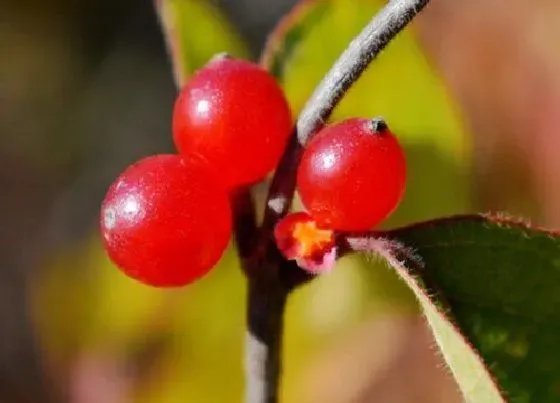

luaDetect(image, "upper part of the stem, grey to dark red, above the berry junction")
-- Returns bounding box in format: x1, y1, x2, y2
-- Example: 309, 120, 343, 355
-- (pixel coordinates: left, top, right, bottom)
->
263, 0, 429, 231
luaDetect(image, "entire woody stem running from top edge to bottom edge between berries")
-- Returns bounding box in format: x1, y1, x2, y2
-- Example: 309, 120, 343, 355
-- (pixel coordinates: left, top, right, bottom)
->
243, 0, 429, 403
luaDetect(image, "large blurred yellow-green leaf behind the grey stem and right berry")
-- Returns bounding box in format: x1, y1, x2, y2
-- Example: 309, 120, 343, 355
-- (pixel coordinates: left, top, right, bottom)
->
262, 0, 474, 226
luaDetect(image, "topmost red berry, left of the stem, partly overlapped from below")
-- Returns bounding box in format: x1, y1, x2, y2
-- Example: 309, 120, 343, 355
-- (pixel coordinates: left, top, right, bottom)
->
173, 57, 292, 187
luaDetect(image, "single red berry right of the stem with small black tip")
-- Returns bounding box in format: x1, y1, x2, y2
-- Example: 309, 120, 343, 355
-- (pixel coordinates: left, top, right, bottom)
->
297, 119, 406, 231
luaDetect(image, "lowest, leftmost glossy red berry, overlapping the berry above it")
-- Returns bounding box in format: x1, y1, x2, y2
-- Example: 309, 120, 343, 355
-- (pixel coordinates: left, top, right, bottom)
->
101, 155, 231, 287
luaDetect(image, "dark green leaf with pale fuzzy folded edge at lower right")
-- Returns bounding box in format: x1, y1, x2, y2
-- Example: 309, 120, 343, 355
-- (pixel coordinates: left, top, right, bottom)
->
358, 215, 560, 403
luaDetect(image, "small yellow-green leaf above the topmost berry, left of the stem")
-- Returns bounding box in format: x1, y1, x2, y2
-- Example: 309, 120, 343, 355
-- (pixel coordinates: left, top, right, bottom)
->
154, 0, 248, 86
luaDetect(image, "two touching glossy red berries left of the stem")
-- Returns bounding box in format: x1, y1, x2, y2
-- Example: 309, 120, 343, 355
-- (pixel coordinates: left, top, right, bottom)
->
101, 57, 292, 287
